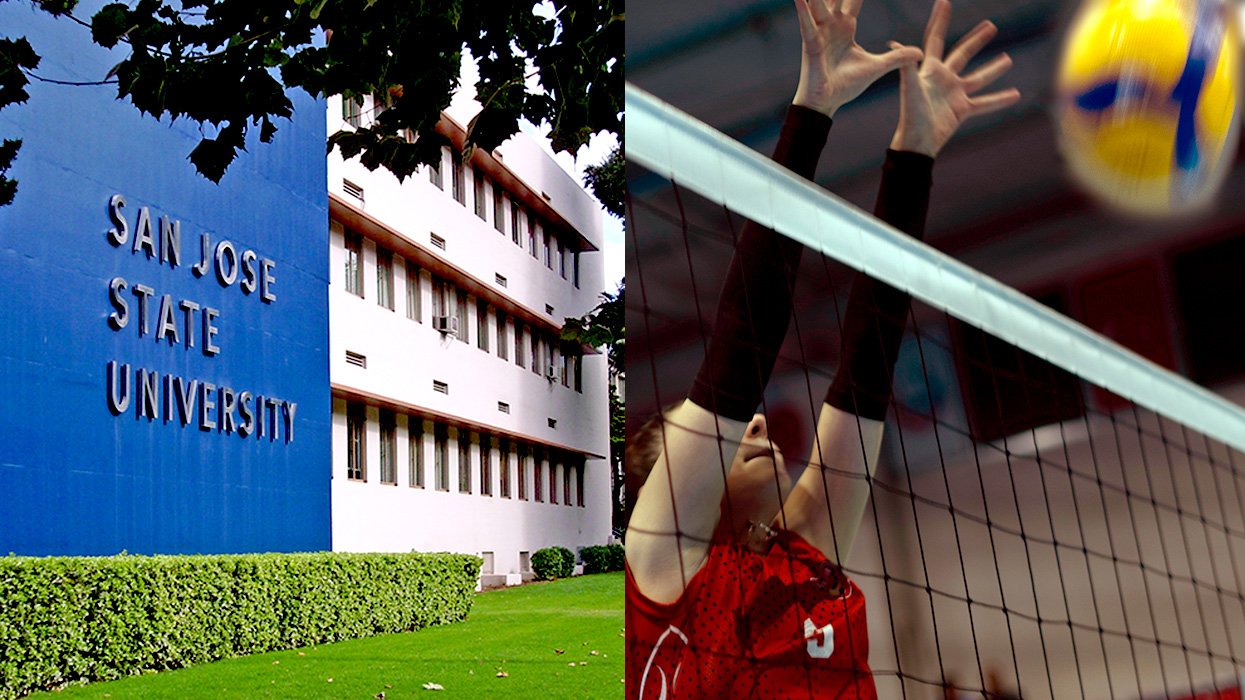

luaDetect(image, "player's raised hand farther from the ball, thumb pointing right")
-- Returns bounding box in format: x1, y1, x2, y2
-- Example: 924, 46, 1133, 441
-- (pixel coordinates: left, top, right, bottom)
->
793, 0, 921, 117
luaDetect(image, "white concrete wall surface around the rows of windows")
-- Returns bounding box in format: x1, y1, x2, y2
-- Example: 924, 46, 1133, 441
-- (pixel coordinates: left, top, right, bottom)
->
329, 98, 610, 560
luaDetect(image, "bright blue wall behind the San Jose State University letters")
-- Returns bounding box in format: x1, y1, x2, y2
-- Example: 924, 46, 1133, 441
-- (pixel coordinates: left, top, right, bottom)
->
0, 2, 331, 554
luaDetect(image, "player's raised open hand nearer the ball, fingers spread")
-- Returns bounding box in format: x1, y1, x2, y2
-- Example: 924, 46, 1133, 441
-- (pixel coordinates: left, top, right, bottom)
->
890, 0, 1020, 157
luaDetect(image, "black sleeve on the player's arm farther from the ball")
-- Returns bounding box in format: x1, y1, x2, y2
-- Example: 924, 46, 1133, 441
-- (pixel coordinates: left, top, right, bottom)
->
688, 106, 832, 421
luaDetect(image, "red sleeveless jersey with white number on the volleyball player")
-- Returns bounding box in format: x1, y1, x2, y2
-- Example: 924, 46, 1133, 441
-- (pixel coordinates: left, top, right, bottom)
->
626, 531, 878, 700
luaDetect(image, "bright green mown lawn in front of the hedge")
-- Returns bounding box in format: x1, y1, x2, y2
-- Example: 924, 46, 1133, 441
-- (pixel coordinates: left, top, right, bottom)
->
31, 573, 624, 700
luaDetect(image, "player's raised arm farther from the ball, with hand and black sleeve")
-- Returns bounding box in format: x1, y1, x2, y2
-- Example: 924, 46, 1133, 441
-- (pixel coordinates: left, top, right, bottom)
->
626, 0, 920, 603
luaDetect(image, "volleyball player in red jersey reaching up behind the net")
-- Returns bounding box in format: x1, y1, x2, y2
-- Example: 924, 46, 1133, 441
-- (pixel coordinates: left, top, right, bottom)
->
626, 0, 1020, 699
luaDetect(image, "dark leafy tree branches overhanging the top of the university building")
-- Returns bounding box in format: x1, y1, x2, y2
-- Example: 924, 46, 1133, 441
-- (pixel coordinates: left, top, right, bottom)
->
9, 0, 625, 190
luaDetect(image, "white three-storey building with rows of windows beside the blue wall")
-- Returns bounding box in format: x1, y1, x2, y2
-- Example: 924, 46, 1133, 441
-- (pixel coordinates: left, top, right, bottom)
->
327, 97, 610, 584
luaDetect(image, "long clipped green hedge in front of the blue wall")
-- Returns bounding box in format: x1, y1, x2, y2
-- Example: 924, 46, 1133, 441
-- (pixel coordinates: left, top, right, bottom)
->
0, 553, 481, 699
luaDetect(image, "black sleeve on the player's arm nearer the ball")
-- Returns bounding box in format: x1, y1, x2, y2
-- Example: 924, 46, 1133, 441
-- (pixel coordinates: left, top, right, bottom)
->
825, 151, 934, 420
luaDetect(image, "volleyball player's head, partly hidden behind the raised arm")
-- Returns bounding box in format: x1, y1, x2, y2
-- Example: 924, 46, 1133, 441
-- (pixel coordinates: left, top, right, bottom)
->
624, 405, 791, 533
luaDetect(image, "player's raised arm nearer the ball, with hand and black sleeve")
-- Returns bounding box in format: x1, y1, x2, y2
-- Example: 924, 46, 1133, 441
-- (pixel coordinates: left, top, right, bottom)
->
778, 0, 1020, 563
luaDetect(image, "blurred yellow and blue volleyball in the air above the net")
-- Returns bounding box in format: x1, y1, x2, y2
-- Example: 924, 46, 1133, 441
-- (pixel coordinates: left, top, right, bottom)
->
1056, 0, 1240, 214
